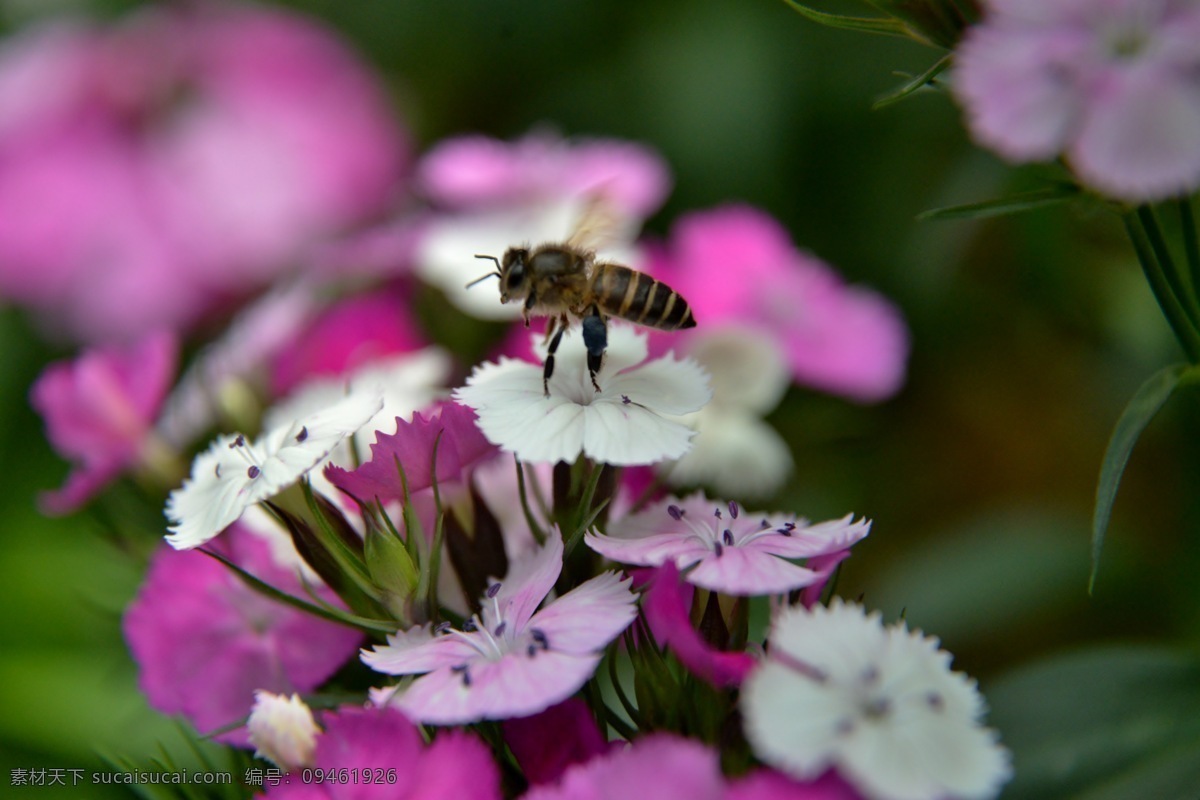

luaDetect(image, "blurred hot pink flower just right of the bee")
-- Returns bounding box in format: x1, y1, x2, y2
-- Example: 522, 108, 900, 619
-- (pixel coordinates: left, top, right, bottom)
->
653, 206, 908, 402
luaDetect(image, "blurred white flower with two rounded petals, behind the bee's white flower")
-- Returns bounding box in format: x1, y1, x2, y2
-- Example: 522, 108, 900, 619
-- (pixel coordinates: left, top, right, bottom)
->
662, 325, 792, 498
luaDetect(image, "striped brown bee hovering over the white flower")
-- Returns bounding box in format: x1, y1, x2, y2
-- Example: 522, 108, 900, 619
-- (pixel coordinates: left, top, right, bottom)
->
467, 201, 696, 397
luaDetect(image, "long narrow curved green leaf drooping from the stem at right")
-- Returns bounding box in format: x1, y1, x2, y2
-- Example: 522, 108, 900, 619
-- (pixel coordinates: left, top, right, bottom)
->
1087, 363, 1188, 593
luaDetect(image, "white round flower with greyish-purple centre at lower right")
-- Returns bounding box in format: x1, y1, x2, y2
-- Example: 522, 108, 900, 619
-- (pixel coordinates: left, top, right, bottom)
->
742, 600, 1012, 800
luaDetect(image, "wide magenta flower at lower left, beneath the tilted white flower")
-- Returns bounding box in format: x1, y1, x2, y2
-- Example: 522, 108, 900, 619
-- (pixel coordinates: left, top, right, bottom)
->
124, 524, 362, 746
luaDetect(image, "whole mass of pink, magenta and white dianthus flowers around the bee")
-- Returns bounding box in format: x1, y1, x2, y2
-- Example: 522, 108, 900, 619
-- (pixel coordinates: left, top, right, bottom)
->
11, 5, 1010, 800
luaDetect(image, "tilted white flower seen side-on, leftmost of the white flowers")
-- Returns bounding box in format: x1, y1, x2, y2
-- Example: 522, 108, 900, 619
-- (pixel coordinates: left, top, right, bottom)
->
166, 393, 383, 549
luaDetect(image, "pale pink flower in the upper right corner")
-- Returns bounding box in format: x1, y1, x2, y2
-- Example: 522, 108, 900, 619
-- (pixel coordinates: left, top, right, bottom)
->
954, 0, 1200, 203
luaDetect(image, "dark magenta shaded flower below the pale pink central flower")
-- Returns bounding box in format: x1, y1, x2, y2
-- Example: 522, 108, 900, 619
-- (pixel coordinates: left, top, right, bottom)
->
500, 697, 608, 784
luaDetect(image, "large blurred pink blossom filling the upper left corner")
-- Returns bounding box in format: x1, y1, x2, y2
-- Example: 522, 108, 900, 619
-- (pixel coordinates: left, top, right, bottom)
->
0, 4, 407, 341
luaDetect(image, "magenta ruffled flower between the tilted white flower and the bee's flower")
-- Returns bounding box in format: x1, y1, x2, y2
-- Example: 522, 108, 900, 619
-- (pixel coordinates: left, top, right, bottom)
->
325, 403, 497, 503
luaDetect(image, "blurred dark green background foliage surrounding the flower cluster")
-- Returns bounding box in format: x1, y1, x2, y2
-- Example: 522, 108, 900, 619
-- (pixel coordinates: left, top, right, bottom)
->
0, 0, 1200, 798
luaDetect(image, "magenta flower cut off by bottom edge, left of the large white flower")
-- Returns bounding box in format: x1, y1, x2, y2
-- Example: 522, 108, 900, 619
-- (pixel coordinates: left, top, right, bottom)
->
523, 734, 725, 800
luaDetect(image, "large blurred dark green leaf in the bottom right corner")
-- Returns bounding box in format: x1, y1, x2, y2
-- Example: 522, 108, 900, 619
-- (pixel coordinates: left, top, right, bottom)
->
986, 645, 1200, 800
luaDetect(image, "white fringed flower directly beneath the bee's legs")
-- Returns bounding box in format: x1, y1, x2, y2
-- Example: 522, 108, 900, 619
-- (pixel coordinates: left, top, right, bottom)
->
455, 325, 712, 465
